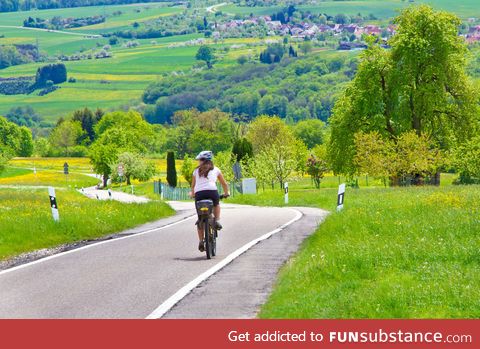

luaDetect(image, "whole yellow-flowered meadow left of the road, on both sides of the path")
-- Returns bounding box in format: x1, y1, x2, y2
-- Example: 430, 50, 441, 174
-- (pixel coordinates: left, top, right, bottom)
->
0, 158, 181, 260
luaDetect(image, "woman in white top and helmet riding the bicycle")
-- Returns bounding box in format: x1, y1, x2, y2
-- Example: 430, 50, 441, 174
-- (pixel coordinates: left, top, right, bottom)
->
190, 151, 230, 252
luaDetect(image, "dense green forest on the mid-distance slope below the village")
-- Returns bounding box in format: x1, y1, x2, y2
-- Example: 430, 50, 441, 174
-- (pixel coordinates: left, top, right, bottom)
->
142, 50, 357, 124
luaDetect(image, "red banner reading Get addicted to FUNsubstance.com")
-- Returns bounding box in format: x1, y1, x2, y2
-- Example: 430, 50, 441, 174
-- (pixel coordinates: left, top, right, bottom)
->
0, 320, 480, 349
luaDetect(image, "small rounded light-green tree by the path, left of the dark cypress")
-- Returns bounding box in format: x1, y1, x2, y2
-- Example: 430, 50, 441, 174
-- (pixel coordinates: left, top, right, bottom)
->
110, 152, 155, 185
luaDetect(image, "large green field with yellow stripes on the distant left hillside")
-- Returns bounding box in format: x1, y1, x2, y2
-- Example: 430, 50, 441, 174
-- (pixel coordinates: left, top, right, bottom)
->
0, 34, 270, 121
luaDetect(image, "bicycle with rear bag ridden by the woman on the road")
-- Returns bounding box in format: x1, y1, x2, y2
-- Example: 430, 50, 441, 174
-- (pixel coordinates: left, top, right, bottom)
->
195, 194, 228, 259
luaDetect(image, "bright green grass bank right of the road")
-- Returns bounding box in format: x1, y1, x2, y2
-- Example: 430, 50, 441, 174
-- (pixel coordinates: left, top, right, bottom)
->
231, 186, 480, 318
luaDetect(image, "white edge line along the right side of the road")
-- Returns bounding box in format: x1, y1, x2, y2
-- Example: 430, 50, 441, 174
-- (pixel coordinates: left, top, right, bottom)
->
146, 208, 303, 319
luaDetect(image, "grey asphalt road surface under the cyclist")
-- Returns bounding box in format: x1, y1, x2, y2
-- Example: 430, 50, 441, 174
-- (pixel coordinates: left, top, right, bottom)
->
0, 204, 326, 318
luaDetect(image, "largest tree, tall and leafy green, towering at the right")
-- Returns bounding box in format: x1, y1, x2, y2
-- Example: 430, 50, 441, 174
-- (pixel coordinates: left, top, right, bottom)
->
329, 5, 479, 175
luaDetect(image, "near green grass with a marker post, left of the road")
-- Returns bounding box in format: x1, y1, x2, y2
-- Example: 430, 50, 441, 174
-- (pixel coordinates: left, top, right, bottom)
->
0, 188, 173, 260
